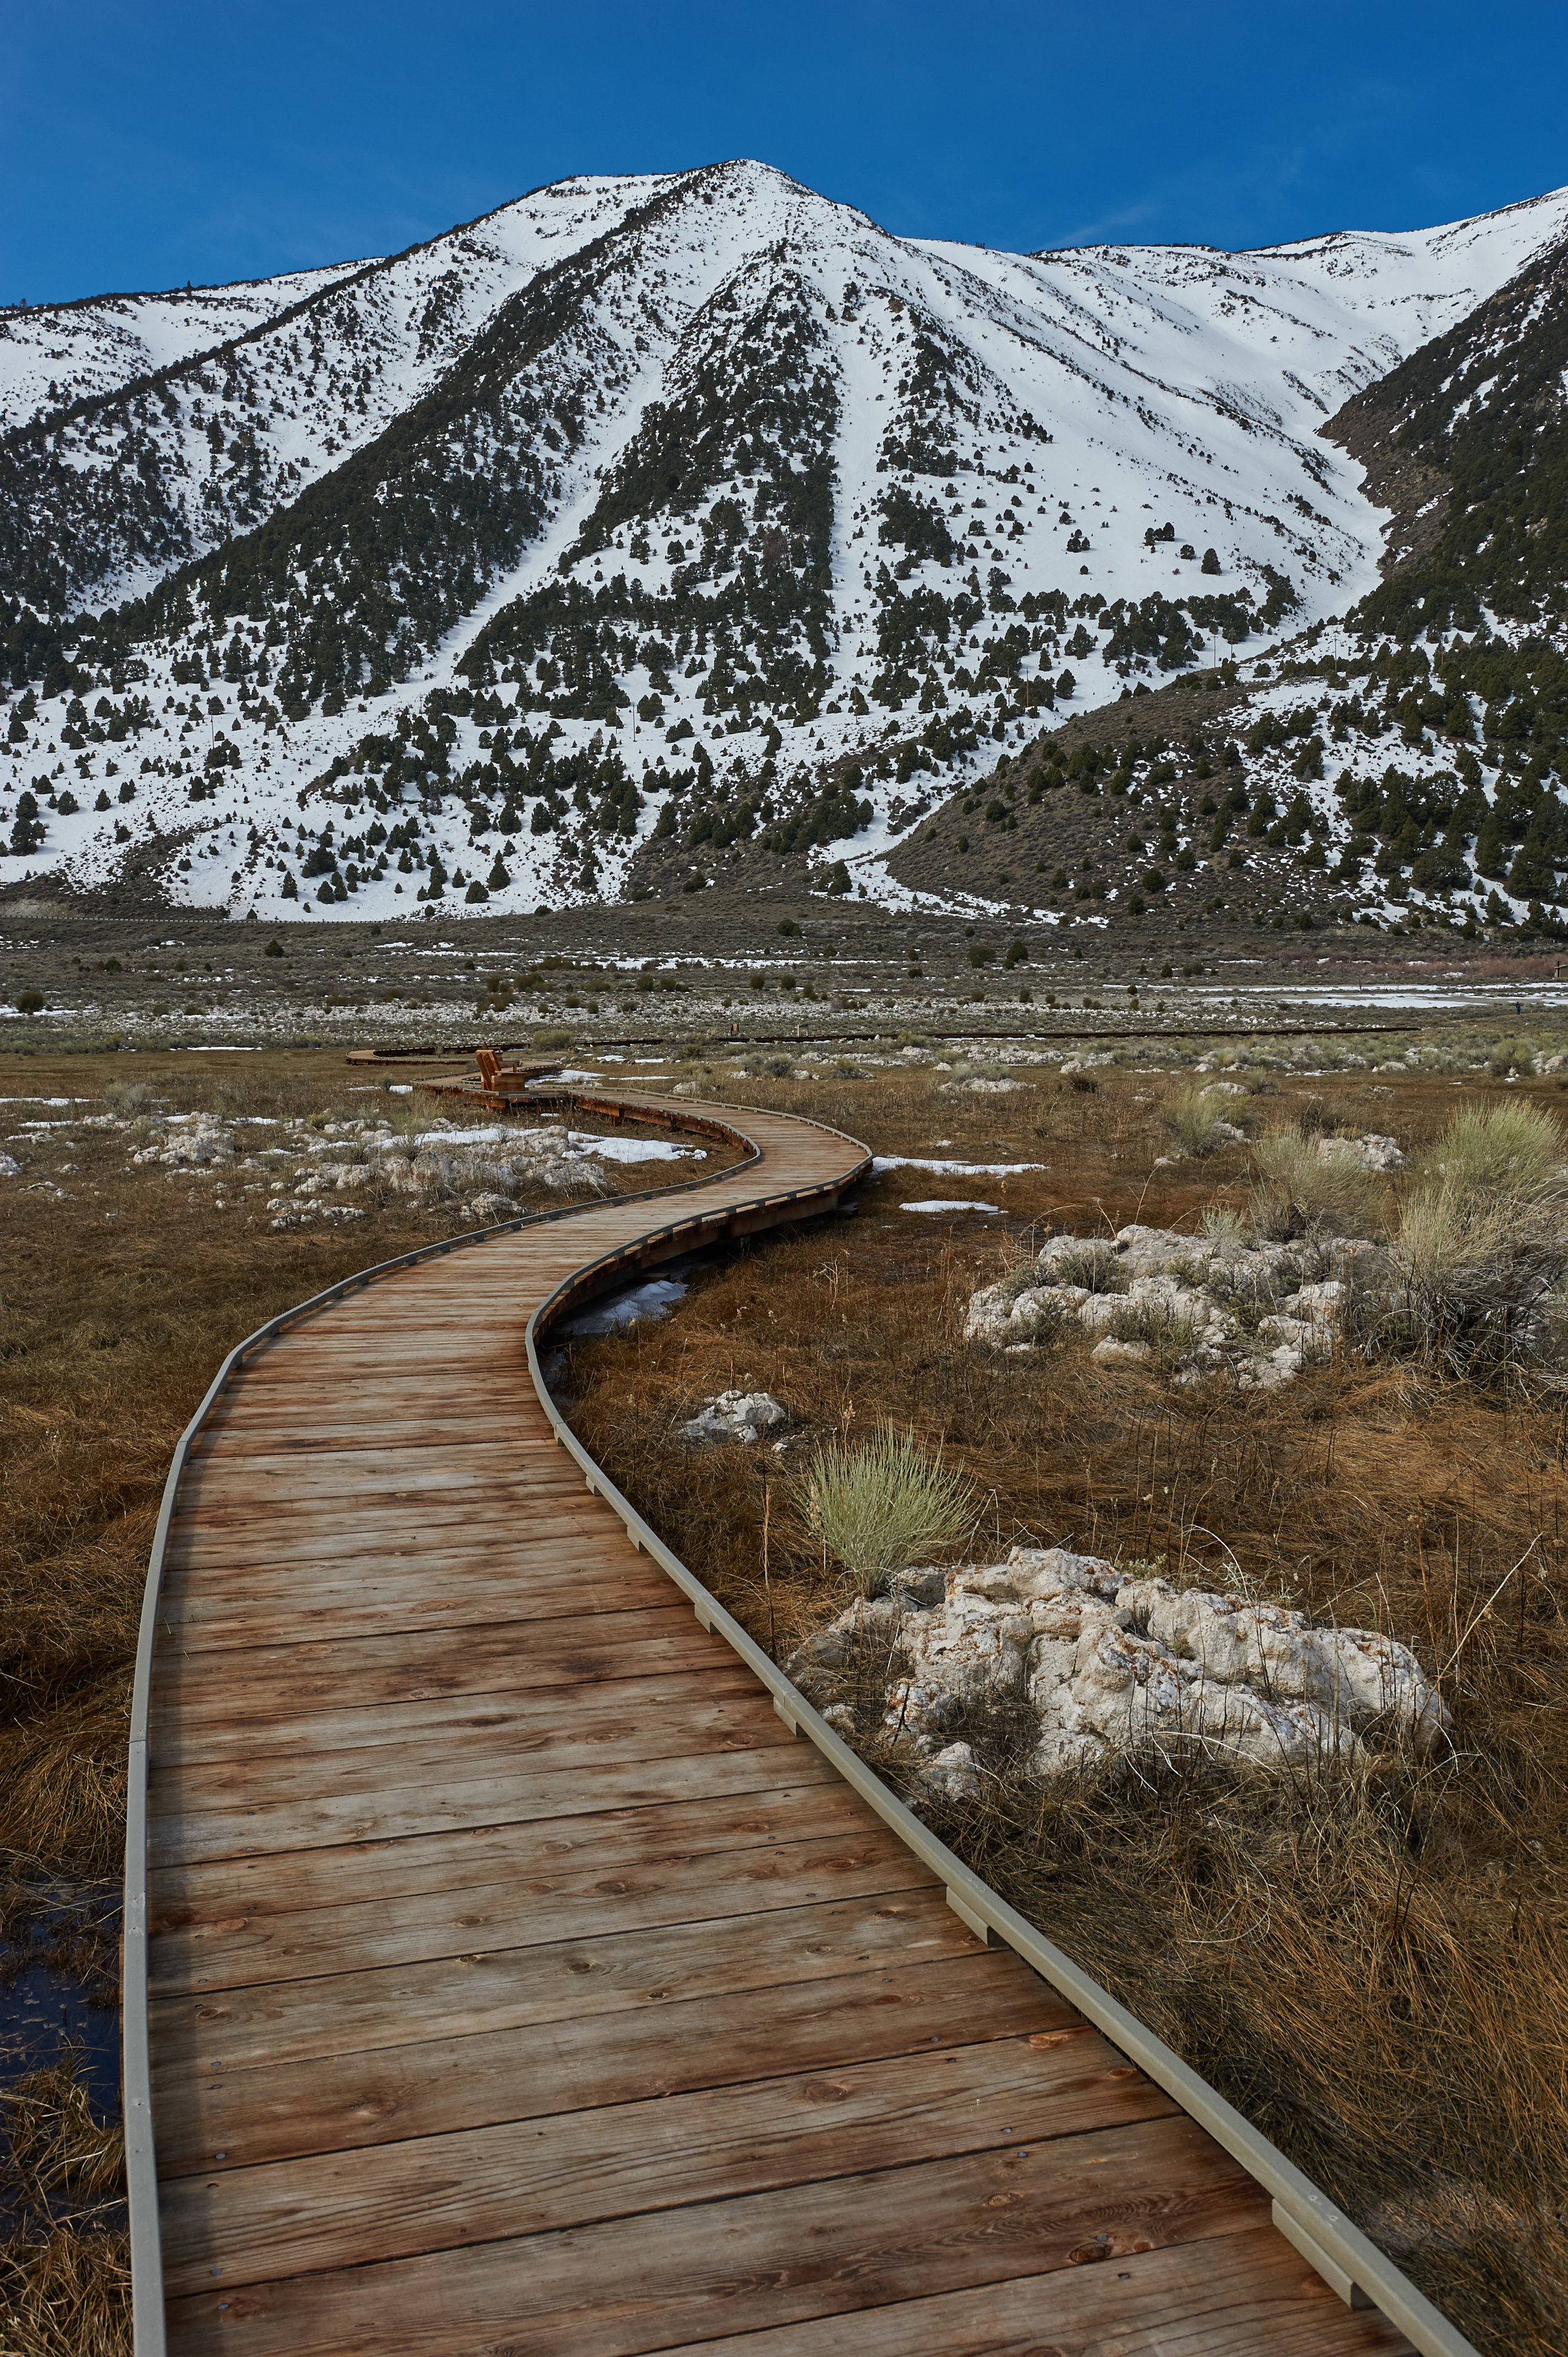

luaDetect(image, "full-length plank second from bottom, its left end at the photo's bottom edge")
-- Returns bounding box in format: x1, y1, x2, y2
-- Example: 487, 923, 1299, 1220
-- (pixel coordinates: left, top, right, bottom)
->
170, 2119, 1266, 2357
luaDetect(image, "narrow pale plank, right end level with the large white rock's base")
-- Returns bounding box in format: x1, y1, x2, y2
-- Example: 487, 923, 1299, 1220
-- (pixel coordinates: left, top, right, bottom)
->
149, 1721, 832, 1867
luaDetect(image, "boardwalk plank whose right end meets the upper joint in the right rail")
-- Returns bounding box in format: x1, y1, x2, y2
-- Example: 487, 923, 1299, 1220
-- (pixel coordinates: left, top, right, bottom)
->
151, 1827, 931, 1992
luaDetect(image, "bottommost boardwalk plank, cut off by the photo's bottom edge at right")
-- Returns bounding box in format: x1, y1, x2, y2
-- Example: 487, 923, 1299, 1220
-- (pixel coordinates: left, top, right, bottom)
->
667, 2225, 1410, 2357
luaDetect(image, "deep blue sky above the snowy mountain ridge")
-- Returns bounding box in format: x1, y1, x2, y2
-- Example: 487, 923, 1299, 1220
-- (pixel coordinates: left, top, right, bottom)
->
0, 0, 1568, 302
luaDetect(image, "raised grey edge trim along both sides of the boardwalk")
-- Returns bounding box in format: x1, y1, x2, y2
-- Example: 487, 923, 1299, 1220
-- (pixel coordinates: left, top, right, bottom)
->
120, 1089, 1476, 2357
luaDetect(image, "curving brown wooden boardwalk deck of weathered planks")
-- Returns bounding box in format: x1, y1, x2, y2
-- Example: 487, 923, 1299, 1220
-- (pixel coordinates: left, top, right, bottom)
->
149, 1108, 1407, 2357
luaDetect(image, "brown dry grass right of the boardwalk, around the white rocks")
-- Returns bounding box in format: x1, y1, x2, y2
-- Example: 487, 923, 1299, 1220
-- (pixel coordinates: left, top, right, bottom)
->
568, 1077, 1568, 2357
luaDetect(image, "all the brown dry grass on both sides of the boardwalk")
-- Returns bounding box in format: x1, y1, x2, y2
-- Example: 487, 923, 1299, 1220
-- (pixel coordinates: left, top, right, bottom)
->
0, 1053, 1568, 2357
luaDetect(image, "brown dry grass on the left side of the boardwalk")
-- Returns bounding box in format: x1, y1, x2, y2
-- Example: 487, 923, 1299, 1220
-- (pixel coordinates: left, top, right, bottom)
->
0, 1053, 744, 2357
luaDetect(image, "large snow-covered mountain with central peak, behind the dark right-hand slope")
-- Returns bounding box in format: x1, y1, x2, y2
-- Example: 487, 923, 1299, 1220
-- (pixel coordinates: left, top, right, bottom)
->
0, 162, 1568, 917
